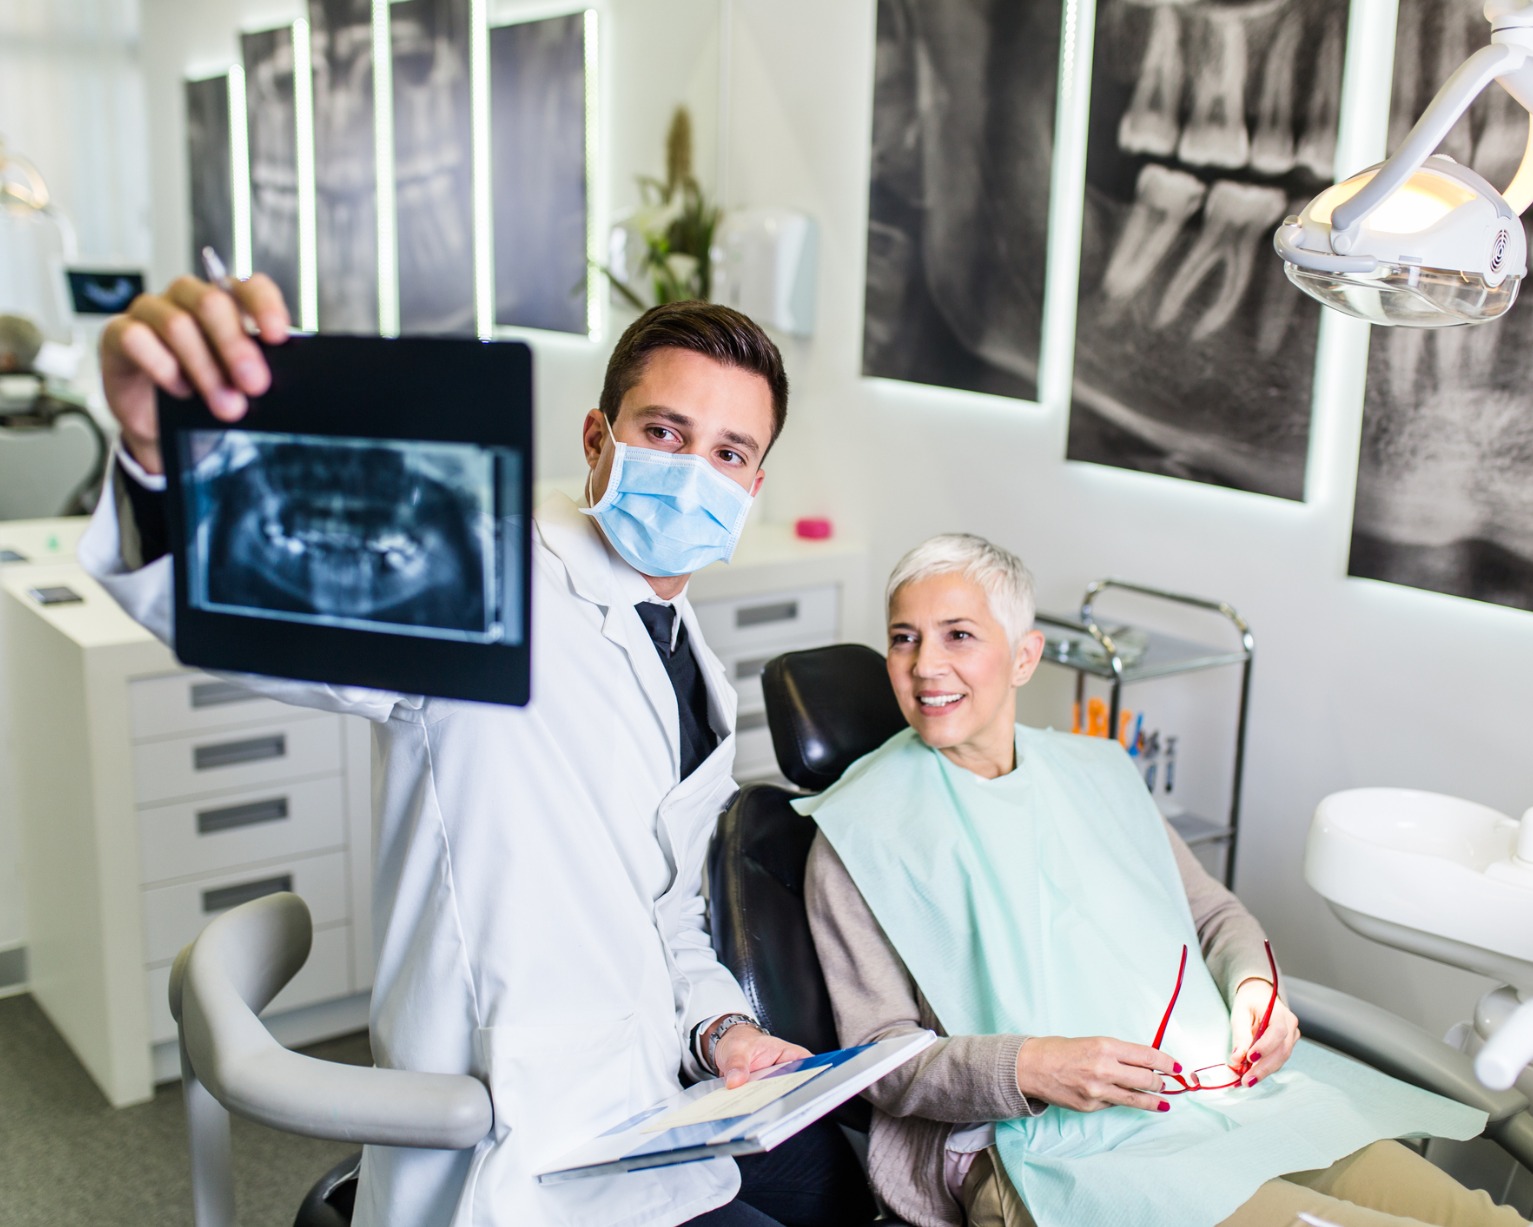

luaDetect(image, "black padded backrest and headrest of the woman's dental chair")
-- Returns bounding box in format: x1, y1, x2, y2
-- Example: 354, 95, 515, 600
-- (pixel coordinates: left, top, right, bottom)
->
708, 644, 904, 1052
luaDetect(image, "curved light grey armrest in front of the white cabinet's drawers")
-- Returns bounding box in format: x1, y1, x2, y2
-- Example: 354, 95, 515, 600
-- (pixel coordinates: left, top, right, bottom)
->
170, 894, 494, 1150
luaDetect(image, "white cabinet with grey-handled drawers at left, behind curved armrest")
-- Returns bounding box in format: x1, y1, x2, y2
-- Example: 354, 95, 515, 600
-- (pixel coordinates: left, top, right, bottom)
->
0, 566, 373, 1106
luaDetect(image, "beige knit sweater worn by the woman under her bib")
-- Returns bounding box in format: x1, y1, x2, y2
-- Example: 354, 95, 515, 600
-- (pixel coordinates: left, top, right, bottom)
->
805, 825, 1269, 1227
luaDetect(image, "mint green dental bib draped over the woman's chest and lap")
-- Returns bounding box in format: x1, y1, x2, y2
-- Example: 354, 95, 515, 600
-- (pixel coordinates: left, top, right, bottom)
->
796, 725, 1485, 1227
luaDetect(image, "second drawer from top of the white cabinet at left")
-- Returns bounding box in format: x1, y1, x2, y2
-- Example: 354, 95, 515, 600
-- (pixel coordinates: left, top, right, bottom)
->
133, 715, 340, 805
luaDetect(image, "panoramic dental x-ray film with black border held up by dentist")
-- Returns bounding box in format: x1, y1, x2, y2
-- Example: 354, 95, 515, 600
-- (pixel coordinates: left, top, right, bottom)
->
159, 337, 532, 704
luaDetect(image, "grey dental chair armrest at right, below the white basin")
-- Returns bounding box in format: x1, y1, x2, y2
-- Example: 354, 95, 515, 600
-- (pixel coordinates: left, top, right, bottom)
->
1283, 975, 1528, 1126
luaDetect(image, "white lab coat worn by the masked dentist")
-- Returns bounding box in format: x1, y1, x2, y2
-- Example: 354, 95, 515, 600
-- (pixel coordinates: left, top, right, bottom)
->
80, 491, 748, 1227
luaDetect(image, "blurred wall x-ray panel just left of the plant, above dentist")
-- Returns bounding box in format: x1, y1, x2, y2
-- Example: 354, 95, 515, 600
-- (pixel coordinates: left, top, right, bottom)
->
489, 14, 586, 333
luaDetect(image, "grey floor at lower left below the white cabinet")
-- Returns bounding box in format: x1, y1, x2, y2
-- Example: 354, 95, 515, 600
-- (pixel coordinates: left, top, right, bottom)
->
0, 995, 371, 1227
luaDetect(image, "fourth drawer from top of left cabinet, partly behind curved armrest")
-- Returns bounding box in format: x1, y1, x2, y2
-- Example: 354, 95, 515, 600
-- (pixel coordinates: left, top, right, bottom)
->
144, 853, 351, 963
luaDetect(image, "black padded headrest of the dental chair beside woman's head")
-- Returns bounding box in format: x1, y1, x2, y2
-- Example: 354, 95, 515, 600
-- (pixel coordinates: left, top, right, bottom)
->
762, 643, 904, 791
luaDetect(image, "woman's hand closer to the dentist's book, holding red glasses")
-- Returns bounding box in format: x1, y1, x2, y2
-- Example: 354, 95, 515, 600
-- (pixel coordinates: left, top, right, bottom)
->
1016, 1036, 1177, 1112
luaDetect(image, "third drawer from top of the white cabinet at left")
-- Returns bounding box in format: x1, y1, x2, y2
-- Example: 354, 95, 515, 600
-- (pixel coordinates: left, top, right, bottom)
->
138, 776, 346, 882
